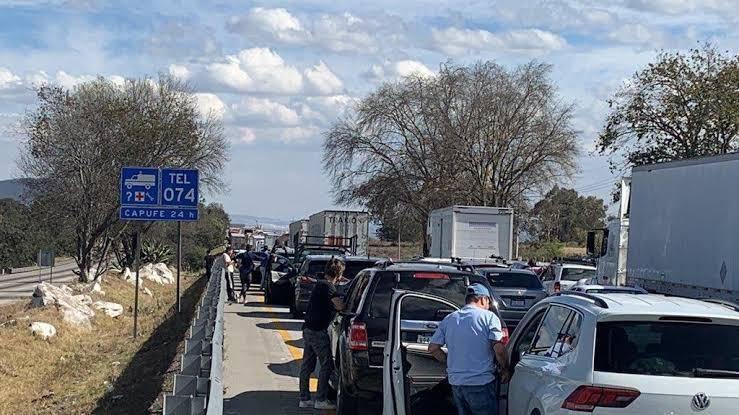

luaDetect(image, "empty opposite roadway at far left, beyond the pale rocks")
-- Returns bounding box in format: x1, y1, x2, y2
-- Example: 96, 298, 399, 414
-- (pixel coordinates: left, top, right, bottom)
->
0, 259, 77, 305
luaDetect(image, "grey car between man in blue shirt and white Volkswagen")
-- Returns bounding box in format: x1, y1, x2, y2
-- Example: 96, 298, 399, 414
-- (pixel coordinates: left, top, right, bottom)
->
485, 269, 547, 328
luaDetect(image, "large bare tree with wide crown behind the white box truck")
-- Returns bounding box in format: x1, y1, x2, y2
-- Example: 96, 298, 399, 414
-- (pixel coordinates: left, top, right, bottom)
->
323, 62, 578, 255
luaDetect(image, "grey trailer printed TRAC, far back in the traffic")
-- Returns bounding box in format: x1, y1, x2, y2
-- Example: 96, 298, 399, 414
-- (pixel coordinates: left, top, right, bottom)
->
306, 210, 369, 256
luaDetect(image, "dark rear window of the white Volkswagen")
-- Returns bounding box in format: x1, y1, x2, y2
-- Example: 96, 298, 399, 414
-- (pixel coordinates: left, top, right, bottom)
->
595, 321, 739, 378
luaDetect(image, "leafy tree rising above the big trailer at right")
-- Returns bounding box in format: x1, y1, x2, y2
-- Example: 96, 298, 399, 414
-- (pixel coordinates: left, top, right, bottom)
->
597, 44, 739, 170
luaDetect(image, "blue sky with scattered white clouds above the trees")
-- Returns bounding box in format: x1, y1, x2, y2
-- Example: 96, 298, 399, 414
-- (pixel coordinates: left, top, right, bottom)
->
0, 0, 739, 219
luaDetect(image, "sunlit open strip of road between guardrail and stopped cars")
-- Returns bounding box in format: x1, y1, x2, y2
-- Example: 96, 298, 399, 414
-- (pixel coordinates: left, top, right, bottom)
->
223, 286, 333, 415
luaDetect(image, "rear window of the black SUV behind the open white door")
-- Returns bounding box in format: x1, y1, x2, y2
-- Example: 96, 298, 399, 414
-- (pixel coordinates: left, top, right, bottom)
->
370, 272, 489, 318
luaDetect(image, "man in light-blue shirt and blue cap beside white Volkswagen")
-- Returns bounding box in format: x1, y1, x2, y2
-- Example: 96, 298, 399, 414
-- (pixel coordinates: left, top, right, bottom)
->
429, 284, 510, 415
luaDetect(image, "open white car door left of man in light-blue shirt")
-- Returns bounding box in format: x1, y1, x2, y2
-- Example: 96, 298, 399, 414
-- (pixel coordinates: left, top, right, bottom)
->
382, 290, 459, 415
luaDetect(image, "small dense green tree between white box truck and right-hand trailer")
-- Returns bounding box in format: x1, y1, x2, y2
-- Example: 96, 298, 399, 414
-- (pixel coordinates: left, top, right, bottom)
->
528, 186, 606, 244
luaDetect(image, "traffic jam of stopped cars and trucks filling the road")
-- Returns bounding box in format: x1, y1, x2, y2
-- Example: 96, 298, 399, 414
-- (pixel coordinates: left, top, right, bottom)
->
233, 157, 739, 415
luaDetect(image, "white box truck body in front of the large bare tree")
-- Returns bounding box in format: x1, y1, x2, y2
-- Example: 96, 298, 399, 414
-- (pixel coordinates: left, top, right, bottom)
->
427, 206, 514, 260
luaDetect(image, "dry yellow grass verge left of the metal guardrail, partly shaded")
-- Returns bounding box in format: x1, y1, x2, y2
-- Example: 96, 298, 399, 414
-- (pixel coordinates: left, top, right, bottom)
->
0, 277, 204, 414
